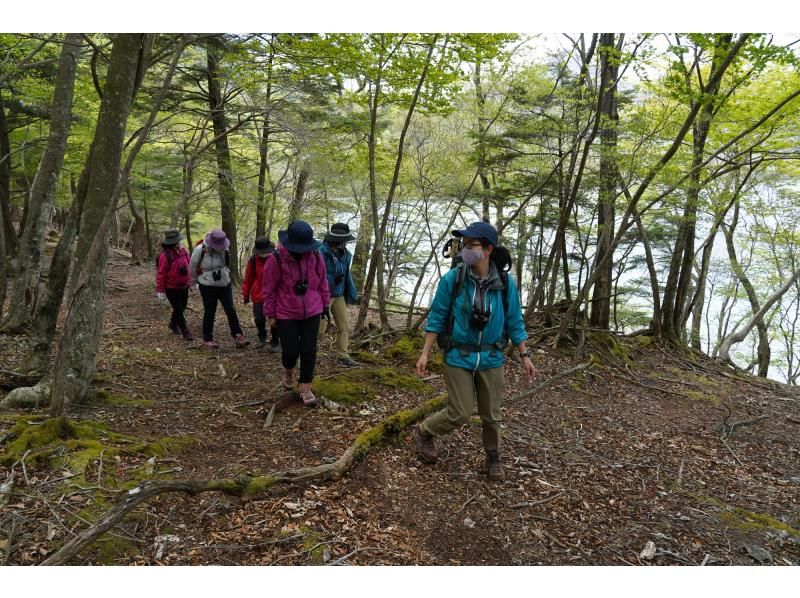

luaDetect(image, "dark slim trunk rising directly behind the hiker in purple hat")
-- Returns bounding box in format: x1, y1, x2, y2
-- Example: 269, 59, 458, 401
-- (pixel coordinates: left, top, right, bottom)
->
206, 38, 241, 285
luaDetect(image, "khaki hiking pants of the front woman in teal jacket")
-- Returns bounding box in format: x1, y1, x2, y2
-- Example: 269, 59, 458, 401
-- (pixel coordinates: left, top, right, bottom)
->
420, 364, 505, 451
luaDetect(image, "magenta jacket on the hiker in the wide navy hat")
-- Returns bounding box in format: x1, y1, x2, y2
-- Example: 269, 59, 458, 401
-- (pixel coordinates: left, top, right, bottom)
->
261, 246, 331, 320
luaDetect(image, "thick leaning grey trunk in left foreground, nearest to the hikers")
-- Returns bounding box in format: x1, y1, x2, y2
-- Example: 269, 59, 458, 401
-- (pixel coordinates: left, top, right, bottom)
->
50, 34, 148, 417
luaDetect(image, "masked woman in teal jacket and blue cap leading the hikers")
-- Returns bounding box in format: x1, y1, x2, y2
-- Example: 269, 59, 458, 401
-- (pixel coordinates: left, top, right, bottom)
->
413, 222, 536, 480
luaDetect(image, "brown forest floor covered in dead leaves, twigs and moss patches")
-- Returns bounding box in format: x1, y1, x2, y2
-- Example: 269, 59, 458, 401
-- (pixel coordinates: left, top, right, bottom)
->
0, 256, 800, 565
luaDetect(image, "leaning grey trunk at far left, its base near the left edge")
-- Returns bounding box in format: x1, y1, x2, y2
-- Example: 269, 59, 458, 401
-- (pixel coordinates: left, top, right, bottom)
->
3, 33, 83, 332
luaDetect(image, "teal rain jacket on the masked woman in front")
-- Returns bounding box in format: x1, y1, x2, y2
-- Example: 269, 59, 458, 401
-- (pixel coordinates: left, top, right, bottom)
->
425, 268, 528, 371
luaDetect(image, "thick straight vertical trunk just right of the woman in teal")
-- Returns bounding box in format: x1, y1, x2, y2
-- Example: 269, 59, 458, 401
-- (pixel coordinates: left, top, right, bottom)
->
589, 33, 622, 330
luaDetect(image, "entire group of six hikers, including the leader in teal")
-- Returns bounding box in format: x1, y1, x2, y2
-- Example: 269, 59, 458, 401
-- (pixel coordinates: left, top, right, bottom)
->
156, 220, 536, 481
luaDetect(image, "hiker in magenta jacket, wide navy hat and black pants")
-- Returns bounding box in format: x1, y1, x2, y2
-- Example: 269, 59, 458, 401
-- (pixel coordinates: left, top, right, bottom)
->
261, 220, 331, 406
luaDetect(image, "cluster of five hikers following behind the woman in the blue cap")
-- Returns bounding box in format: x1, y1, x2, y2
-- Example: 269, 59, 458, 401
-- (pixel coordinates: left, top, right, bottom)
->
156, 220, 358, 406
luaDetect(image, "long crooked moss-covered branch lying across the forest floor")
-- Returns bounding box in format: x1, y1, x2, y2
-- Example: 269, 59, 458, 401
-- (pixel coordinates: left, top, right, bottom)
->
42, 396, 445, 565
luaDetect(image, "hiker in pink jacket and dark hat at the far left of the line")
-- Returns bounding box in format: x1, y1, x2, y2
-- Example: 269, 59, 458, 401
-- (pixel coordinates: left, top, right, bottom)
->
156, 228, 194, 341
